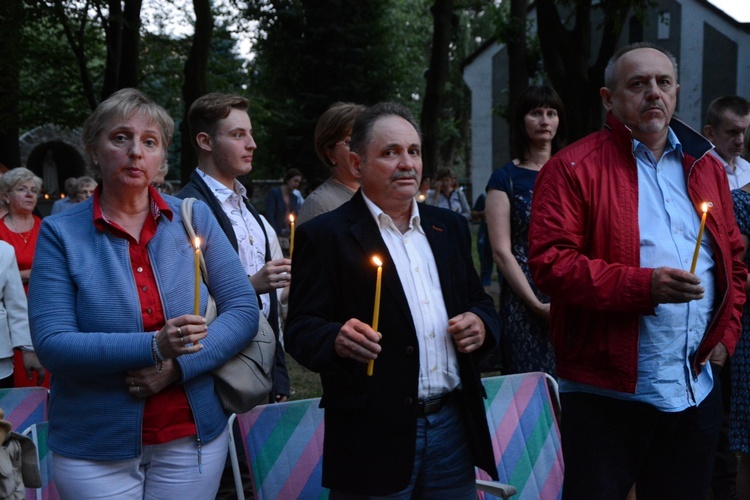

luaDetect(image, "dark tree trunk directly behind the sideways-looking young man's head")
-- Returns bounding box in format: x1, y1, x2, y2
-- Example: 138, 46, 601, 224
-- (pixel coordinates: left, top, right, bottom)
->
180, 0, 214, 184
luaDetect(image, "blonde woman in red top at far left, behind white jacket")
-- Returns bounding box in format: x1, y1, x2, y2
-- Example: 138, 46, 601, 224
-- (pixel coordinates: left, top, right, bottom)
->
0, 167, 49, 388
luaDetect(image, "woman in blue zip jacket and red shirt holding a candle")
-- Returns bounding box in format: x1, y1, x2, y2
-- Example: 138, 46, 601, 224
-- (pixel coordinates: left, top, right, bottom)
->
29, 89, 258, 499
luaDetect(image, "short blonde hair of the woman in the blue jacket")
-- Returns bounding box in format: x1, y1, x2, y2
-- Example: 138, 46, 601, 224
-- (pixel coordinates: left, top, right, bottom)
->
81, 88, 174, 180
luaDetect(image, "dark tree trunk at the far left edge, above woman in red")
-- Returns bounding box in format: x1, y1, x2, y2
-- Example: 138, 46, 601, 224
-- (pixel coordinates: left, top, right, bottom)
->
0, 0, 24, 168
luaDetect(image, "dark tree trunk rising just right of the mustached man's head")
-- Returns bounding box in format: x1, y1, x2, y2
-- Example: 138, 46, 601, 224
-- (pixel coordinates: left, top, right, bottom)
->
421, 0, 453, 177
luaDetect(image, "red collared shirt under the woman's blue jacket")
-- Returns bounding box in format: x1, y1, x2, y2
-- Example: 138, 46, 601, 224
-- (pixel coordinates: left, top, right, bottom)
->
93, 185, 197, 445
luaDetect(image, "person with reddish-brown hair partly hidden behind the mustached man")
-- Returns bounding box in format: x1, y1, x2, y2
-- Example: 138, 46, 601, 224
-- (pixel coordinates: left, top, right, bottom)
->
297, 102, 365, 224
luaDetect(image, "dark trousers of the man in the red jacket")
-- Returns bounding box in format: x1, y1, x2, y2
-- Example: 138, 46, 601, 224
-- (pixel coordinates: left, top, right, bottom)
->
561, 370, 721, 500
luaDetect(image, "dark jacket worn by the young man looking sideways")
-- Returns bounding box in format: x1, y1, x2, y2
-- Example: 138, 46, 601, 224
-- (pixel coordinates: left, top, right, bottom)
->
175, 171, 290, 402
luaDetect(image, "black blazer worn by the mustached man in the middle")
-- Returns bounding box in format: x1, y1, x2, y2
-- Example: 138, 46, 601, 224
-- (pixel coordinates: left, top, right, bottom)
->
284, 191, 499, 495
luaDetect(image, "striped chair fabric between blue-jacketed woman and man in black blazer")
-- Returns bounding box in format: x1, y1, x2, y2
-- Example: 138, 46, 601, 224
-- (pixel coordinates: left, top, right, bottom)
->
237, 398, 328, 500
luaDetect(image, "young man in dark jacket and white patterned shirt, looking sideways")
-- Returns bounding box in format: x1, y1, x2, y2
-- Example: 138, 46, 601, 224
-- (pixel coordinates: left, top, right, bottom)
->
177, 93, 291, 402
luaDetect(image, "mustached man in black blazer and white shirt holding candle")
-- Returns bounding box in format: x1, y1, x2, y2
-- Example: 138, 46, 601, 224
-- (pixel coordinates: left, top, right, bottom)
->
284, 103, 498, 498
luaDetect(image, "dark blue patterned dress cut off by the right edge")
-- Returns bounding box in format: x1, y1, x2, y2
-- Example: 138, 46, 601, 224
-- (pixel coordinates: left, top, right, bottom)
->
729, 186, 750, 498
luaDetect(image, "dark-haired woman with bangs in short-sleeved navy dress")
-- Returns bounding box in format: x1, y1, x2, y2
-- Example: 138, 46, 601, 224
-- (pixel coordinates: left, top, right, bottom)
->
485, 86, 566, 376
